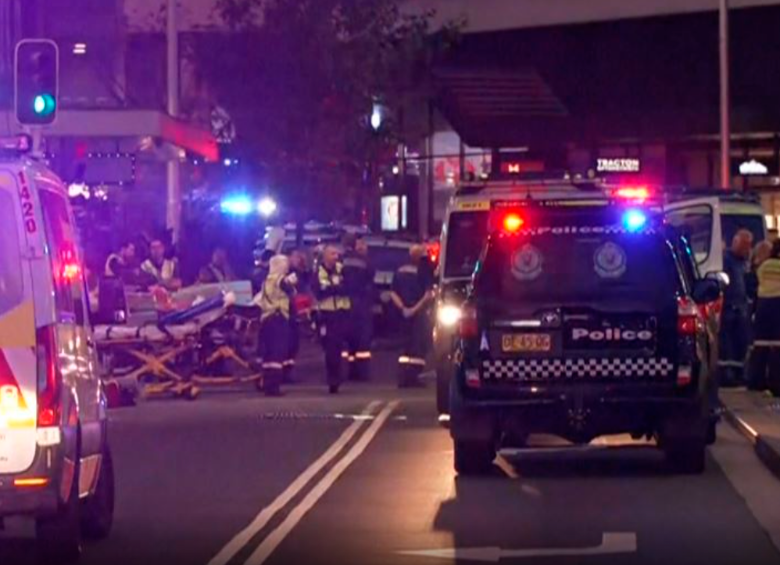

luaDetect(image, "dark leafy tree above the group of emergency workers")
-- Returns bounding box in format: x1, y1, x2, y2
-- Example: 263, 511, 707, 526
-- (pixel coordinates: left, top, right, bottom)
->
188, 0, 455, 225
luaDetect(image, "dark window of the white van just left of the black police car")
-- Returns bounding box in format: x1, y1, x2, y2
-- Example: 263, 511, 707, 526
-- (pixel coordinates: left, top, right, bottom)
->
444, 212, 488, 278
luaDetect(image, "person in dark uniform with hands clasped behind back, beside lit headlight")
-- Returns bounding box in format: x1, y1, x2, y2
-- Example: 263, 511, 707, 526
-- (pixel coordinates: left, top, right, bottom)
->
390, 245, 433, 388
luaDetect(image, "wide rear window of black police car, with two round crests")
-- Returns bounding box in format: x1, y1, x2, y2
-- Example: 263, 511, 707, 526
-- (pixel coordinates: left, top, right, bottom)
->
477, 233, 682, 305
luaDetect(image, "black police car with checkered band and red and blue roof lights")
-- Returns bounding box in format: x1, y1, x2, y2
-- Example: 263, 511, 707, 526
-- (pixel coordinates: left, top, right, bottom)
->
449, 190, 721, 474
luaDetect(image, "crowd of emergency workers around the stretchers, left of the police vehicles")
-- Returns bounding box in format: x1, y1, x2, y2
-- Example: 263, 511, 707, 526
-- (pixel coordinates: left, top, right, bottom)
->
94, 228, 435, 396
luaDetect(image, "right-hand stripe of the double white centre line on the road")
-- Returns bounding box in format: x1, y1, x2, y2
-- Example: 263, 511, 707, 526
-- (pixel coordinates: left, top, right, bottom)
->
245, 401, 399, 565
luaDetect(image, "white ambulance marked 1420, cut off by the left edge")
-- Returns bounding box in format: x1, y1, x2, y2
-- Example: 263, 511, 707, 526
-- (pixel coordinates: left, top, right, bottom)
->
0, 137, 114, 563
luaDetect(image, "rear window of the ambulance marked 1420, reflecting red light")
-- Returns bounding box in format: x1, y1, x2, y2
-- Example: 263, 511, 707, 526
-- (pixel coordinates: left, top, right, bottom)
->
40, 190, 85, 325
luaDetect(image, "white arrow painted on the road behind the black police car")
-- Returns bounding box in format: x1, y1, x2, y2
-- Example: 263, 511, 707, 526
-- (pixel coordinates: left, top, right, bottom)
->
397, 533, 636, 563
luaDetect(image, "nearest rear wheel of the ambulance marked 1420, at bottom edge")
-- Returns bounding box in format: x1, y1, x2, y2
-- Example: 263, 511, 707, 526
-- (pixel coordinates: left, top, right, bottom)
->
35, 452, 81, 565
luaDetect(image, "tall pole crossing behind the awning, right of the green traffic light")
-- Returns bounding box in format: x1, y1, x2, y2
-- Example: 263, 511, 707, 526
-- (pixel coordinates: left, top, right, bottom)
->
166, 0, 182, 243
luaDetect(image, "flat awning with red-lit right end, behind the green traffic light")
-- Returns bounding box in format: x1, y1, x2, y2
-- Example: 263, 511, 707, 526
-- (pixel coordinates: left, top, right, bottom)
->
0, 110, 219, 161
